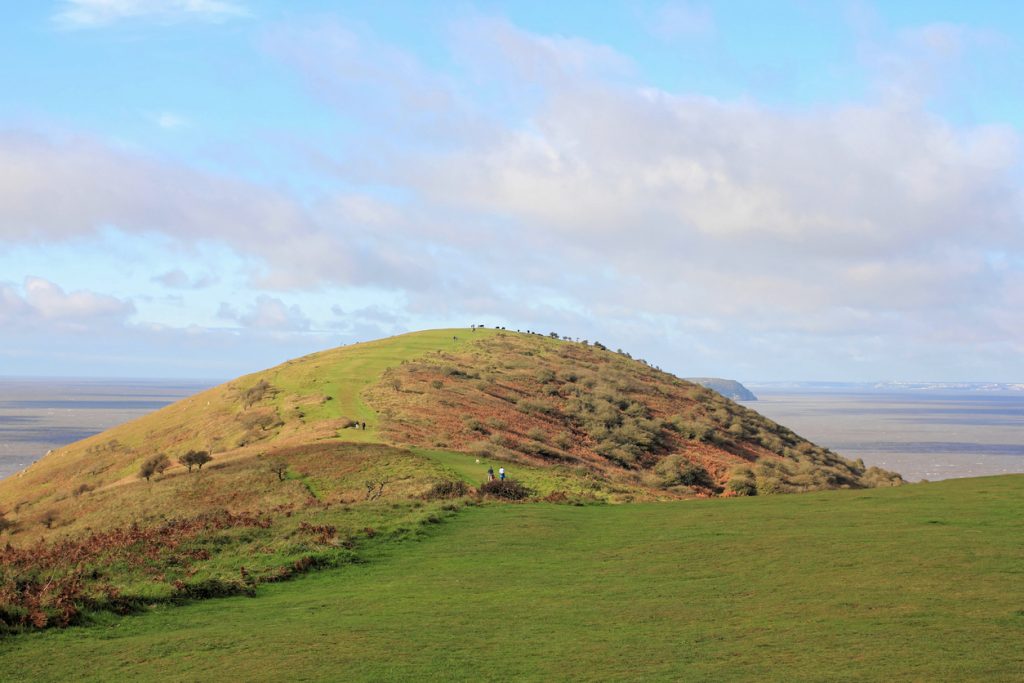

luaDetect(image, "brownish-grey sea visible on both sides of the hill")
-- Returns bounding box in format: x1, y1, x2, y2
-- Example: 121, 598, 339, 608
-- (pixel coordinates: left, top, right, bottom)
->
0, 379, 1024, 481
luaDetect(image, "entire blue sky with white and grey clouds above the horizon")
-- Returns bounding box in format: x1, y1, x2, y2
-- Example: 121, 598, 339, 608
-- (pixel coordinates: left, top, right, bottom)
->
0, 0, 1024, 382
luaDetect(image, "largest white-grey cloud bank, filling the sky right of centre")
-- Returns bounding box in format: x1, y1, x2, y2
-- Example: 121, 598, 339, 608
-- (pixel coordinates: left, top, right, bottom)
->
262, 20, 1024, 378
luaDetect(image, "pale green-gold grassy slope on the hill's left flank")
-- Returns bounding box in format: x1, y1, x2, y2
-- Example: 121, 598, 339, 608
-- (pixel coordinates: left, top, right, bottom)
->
0, 330, 494, 542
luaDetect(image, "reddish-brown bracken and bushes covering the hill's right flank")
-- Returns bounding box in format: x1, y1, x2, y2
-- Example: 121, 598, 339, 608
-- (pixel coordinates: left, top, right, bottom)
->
366, 332, 901, 496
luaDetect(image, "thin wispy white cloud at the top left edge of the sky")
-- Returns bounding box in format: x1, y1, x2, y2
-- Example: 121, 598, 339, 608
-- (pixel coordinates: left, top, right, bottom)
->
53, 0, 248, 29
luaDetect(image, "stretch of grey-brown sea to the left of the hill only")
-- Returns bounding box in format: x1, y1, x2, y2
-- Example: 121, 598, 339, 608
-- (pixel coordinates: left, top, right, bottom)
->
0, 379, 214, 478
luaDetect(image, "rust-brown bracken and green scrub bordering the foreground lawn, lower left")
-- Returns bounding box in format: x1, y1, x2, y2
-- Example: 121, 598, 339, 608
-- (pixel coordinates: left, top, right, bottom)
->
0, 497, 460, 635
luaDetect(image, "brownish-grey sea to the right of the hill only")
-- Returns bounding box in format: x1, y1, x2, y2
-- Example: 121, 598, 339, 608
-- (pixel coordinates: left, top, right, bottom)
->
744, 387, 1024, 481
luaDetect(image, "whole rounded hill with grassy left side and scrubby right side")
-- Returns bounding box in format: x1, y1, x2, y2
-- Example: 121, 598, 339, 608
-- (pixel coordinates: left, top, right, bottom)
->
0, 330, 901, 628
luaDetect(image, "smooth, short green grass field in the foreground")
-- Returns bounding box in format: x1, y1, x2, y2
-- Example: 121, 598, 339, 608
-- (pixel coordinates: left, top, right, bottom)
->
0, 476, 1024, 681
